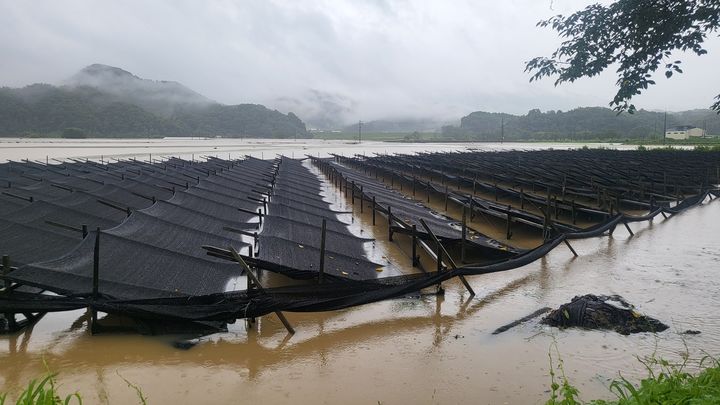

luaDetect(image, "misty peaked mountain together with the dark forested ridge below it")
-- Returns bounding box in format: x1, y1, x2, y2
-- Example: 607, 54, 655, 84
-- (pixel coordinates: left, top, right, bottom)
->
0, 65, 308, 138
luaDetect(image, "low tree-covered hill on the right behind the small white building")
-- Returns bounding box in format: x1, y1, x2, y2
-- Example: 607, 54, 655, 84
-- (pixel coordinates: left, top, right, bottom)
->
443, 107, 720, 141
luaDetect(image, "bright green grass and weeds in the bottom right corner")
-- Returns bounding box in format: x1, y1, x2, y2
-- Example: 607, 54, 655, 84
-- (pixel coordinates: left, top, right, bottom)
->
546, 345, 720, 405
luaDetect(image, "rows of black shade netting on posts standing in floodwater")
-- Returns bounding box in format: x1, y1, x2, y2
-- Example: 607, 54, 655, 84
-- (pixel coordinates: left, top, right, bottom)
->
0, 150, 720, 333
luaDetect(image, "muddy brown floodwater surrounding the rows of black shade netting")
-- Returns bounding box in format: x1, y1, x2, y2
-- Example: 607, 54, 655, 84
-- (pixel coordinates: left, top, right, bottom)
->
0, 140, 720, 404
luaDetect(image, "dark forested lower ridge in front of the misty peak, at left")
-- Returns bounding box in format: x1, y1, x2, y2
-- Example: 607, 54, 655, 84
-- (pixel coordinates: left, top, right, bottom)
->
0, 84, 308, 138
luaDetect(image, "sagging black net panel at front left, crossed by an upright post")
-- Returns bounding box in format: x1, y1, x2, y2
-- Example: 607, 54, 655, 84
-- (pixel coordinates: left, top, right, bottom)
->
11, 232, 241, 299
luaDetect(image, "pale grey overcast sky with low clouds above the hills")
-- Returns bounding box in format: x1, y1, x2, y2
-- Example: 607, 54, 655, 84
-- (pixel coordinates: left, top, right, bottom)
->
0, 0, 720, 122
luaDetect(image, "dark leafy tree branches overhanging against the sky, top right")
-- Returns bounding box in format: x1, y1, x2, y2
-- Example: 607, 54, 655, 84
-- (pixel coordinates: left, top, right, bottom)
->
525, 0, 720, 113
